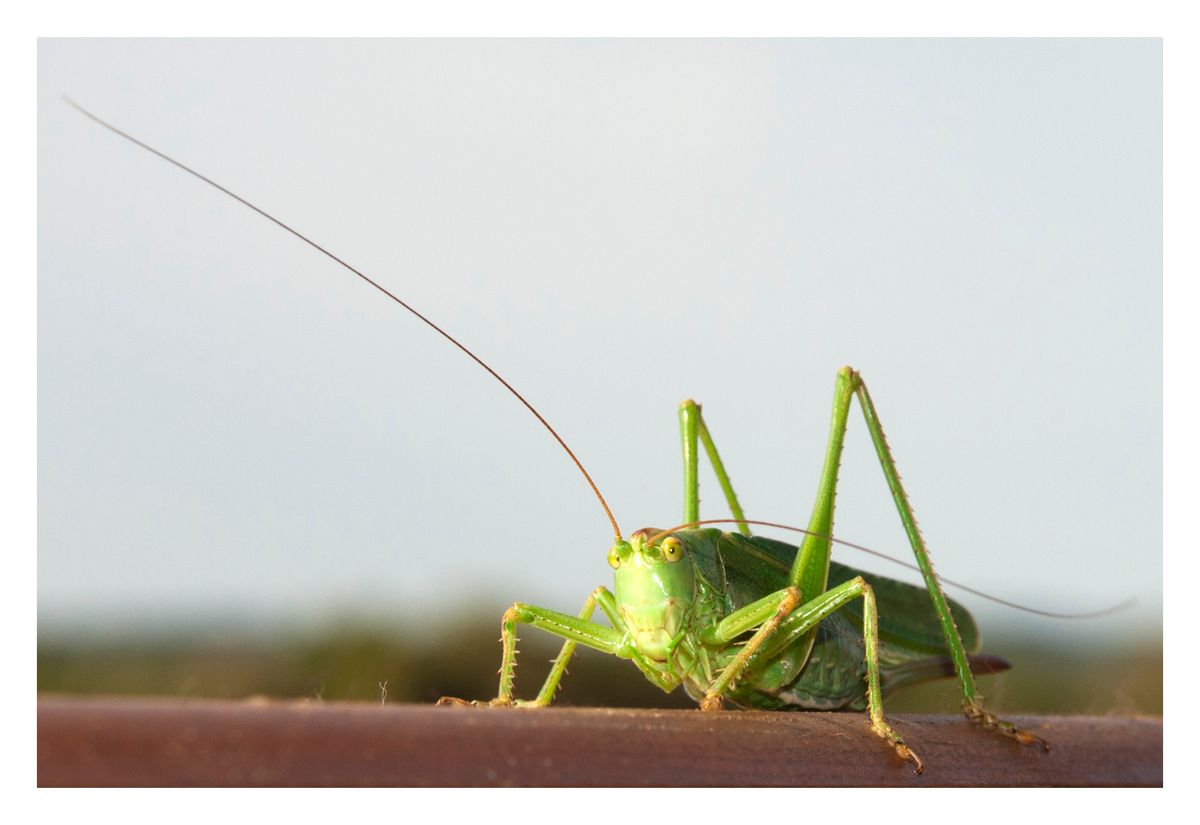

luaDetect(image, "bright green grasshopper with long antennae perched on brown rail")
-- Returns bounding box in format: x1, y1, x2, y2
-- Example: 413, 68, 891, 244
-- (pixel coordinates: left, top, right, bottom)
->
67, 100, 1049, 772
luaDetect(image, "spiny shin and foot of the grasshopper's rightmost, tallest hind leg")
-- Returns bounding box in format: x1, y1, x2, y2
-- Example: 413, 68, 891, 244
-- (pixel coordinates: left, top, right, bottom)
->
859, 376, 1050, 751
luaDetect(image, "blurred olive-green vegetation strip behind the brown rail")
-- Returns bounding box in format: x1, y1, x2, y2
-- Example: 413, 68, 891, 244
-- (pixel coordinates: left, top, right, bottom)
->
37, 616, 1163, 715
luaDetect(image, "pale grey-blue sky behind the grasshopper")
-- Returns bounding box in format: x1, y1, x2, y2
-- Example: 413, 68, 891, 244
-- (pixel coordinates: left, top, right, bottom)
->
38, 40, 1163, 638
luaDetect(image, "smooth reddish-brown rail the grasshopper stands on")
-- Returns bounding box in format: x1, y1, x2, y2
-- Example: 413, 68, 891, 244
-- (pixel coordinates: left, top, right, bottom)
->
37, 698, 1163, 787
